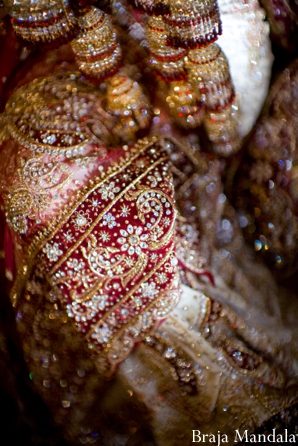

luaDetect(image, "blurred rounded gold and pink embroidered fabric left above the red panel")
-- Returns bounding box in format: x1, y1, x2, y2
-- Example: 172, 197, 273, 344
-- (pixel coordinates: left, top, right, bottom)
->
0, 74, 115, 234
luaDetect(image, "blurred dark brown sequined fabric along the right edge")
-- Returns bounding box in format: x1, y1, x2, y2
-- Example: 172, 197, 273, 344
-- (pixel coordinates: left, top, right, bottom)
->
234, 61, 298, 275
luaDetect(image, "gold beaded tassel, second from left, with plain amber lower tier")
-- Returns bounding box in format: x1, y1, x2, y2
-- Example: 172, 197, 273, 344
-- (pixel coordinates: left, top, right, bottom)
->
72, 7, 151, 143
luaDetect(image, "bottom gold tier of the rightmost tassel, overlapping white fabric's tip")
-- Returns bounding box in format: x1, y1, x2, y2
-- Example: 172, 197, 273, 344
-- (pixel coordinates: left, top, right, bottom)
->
203, 106, 240, 156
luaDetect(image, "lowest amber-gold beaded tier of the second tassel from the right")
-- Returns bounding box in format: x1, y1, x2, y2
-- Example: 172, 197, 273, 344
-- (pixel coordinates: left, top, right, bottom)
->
166, 81, 205, 129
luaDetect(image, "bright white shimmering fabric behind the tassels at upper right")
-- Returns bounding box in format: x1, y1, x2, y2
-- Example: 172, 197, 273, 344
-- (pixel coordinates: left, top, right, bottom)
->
218, 0, 273, 138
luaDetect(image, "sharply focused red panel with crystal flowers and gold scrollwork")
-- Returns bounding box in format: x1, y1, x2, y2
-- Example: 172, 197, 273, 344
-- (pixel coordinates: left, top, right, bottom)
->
18, 143, 179, 368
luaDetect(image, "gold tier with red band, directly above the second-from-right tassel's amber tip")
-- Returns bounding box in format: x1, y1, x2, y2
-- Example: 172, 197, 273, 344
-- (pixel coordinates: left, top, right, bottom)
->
147, 16, 187, 82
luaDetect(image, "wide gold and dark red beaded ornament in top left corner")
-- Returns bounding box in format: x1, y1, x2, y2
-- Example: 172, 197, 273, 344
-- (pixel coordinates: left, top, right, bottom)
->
3, 0, 79, 47
